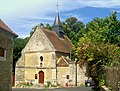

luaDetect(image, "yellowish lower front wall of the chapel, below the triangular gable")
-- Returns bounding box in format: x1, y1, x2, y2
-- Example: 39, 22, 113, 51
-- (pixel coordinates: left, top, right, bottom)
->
15, 52, 56, 85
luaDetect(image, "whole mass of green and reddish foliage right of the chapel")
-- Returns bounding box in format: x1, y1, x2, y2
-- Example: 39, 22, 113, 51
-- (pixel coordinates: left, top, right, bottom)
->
74, 12, 120, 86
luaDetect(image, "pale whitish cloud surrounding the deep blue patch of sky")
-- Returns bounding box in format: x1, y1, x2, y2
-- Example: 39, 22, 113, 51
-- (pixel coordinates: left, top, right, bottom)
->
0, 0, 120, 36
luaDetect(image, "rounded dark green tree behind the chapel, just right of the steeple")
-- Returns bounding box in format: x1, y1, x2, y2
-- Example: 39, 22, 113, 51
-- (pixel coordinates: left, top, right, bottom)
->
62, 17, 85, 44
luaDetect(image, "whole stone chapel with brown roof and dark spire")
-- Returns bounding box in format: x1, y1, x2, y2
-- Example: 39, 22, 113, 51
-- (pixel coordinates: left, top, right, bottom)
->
15, 13, 86, 86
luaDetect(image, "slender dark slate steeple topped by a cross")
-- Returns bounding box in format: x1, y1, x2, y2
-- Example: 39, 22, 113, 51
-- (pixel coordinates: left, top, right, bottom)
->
52, 4, 64, 38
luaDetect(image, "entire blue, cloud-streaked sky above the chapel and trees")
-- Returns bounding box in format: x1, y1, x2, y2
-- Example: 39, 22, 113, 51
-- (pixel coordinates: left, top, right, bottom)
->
0, 0, 120, 38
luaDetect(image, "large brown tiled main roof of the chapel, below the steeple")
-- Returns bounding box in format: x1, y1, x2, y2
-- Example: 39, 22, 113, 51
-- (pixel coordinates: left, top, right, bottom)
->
41, 28, 73, 53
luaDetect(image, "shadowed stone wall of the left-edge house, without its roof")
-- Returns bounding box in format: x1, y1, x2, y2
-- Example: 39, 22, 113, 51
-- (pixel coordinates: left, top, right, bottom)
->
0, 30, 13, 91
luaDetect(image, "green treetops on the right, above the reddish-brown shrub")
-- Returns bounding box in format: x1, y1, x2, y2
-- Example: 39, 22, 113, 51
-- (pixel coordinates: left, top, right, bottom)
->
85, 12, 120, 46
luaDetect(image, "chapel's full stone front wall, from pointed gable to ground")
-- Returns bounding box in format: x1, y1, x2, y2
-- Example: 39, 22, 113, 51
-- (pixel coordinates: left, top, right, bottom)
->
15, 29, 56, 85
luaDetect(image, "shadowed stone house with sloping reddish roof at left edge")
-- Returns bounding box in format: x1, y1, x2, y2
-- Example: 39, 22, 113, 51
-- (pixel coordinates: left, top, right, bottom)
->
0, 19, 17, 91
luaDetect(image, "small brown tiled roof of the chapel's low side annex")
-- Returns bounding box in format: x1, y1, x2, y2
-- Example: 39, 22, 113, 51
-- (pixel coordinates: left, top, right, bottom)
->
57, 56, 74, 67
